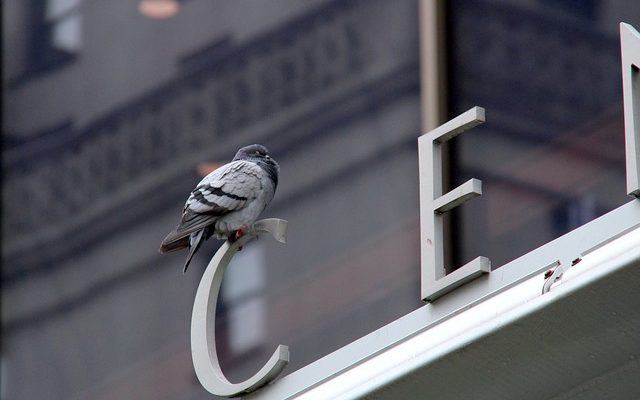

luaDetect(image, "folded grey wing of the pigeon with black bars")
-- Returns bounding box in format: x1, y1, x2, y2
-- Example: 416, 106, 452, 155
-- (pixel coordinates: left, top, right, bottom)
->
160, 160, 262, 252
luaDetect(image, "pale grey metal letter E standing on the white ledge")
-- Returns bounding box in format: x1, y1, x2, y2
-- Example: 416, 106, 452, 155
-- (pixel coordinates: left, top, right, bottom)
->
418, 107, 491, 302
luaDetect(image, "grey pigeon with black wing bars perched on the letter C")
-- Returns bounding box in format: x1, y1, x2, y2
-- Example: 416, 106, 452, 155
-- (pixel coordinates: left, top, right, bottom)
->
160, 144, 280, 272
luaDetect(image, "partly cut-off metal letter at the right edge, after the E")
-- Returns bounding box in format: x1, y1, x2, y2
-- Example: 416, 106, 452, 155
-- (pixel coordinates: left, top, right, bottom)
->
620, 23, 640, 197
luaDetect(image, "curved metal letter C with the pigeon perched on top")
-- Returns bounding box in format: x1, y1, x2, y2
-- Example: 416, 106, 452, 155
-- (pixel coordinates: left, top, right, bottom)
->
191, 218, 289, 397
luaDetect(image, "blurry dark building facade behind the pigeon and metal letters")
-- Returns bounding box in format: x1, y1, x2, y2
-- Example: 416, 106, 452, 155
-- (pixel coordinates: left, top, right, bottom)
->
0, 0, 640, 400
